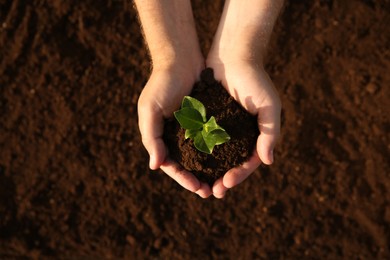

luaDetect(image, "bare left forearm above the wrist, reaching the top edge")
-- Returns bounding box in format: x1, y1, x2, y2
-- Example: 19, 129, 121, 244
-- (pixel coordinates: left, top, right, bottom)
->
135, 0, 201, 67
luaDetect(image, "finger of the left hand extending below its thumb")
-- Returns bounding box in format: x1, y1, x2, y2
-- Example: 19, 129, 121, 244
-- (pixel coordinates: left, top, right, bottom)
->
160, 159, 201, 194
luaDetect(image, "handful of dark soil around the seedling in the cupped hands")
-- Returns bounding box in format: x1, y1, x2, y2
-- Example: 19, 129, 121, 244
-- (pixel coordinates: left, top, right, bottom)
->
164, 68, 259, 186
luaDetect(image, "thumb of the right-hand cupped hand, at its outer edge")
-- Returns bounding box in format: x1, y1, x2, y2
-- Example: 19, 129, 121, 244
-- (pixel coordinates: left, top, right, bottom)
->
256, 103, 281, 165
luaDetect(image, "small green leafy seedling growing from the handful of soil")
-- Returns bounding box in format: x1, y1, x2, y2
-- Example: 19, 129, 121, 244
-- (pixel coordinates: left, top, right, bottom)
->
174, 96, 230, 154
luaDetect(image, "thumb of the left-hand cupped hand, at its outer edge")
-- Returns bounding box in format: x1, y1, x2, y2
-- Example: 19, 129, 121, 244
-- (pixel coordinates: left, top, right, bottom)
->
138, 100, 167, 170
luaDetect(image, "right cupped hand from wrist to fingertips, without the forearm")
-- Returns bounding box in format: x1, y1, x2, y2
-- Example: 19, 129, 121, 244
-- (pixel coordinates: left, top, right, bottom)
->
207, 58, 281, 198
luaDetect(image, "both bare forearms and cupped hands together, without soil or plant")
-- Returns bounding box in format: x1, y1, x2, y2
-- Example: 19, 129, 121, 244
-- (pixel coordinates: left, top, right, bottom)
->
135, 0, 283, 198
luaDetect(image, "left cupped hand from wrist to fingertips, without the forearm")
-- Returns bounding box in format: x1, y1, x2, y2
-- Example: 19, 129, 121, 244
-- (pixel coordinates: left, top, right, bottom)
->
138, 63, 211, 198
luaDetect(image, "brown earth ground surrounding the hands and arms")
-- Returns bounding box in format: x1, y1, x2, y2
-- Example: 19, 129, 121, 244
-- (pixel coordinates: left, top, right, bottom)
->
0, 0, 390, 259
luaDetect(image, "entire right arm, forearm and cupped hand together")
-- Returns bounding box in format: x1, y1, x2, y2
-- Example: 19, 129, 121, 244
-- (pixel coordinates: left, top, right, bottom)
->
207, 0, 283, 198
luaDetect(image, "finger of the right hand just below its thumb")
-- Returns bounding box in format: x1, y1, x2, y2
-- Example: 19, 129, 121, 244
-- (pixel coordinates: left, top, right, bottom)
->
223, 151, 261, 189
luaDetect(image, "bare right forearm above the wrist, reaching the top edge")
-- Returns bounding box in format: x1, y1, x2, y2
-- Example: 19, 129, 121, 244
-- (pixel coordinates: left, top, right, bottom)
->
209, 0, 283, 60
